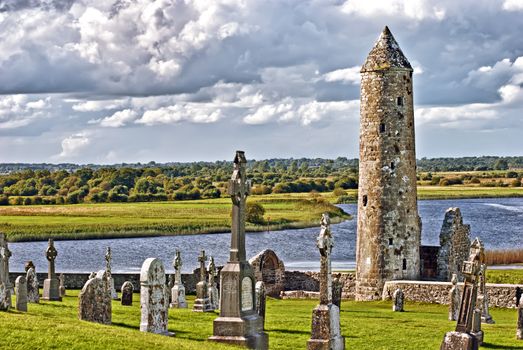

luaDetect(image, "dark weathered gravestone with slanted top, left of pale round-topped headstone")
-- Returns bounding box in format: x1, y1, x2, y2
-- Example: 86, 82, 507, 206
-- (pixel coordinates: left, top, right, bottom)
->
78, 270, 112, 324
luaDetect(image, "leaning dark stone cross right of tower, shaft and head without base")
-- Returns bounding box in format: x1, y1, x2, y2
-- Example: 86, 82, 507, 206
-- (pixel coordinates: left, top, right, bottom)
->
456, 238, 485, 333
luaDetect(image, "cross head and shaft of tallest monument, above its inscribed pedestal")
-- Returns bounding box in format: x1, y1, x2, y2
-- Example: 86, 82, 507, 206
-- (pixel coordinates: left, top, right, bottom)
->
228, 151, 251, 262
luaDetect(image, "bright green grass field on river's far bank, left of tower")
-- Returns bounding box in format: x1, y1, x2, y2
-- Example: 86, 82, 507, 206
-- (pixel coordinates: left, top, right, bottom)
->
0, 196, 350, 241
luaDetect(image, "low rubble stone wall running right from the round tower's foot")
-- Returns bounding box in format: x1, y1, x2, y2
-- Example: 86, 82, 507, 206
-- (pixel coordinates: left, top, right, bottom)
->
382, 281, 523, 309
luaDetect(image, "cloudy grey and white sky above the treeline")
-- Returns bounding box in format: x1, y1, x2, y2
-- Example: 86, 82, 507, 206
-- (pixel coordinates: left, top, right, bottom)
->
0, 0, 523, 163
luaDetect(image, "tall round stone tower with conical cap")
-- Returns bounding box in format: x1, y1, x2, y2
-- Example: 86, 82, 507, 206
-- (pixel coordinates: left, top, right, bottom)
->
356, 27, 421, 300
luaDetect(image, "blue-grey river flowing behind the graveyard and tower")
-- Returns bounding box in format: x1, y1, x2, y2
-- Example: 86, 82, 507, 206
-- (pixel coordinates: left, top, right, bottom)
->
9, 198, 523, 273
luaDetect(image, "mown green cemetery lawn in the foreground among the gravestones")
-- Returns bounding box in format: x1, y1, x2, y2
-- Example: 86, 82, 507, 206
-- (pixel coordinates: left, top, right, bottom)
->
0, 291, 523, 350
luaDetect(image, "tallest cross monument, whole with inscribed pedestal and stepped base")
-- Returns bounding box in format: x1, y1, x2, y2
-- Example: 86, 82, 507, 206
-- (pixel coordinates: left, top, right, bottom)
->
209, 151, 269, 349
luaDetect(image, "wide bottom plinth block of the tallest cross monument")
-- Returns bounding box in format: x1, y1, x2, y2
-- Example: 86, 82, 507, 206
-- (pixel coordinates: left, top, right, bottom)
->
209, 314, 269, 350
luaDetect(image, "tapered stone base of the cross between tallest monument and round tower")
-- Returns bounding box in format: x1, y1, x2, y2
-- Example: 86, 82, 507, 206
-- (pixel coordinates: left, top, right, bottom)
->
307, 304, 345, 350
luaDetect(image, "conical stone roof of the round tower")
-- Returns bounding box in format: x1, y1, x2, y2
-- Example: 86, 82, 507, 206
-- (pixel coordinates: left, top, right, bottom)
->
361, 26, 412, 72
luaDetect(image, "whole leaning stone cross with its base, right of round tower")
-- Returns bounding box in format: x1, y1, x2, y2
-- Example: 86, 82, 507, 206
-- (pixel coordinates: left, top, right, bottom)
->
440, 238, 485, 350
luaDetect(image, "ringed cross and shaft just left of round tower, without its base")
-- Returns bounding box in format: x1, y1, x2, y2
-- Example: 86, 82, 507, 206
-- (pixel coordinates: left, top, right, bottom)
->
316, 214, 334, 305
